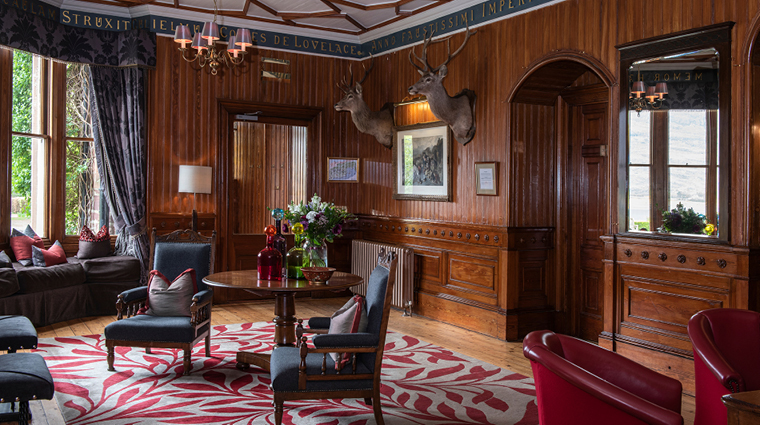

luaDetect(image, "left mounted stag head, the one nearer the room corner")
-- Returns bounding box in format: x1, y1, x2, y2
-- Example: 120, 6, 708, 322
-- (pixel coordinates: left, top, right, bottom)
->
335, 58, 393, 148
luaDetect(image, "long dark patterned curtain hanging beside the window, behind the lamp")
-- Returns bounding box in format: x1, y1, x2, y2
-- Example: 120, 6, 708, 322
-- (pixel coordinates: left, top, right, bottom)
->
90, 66, 150, 281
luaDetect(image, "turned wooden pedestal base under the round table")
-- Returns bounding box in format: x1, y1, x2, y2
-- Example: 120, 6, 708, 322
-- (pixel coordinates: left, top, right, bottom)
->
235, 292, 296, 372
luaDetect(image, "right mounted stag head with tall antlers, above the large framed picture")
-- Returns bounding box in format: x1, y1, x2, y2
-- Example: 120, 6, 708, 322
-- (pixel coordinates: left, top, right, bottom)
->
409, 24, 477, 145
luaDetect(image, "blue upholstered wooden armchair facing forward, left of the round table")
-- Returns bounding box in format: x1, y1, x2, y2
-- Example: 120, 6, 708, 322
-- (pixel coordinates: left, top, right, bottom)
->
105, 228, 216, 375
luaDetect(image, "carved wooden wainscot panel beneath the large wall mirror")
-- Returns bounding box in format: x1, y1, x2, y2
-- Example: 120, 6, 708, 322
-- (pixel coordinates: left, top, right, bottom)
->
599, 235, 760, 394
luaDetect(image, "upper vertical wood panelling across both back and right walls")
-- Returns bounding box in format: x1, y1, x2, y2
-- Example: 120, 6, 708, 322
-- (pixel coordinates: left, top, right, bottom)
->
149, 0, 760, 238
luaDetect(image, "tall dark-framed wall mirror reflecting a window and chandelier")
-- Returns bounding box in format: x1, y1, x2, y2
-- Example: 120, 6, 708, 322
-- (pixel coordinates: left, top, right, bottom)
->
618, 23, 733, 241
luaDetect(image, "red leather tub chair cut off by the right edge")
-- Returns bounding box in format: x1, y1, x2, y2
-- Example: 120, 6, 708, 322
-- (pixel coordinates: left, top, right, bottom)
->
688, 308, 760, 425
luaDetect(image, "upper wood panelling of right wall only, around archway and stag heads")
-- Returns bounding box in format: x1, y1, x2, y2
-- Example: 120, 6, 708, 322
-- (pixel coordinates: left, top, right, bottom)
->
359, 0, 760, 244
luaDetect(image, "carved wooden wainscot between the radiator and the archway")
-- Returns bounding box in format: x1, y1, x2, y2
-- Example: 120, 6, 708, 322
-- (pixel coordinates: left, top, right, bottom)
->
359, 216, 556, 340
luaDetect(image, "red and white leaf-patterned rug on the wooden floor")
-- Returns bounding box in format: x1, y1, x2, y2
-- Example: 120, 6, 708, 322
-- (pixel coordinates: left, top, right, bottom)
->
37, 322, 538, 425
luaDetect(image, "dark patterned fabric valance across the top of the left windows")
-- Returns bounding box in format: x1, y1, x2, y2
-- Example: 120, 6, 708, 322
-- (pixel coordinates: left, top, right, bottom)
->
0, 2, 156, 68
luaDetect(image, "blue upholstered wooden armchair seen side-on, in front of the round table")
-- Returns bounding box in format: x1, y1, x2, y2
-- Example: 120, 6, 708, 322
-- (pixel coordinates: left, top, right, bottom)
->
270, 251, 396, 425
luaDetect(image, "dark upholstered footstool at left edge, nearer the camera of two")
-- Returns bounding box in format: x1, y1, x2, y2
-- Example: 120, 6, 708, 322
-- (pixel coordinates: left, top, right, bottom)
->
0, 353, 55, 425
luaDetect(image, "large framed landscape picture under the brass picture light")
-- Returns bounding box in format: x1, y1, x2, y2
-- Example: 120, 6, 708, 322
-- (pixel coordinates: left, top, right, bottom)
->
393, 121, 452, 202
